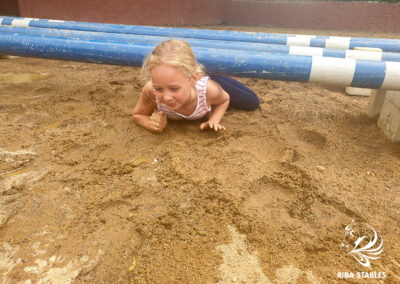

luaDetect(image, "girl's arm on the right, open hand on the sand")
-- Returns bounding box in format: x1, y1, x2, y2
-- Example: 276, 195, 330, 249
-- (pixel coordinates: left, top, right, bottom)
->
200, 79, 229, 131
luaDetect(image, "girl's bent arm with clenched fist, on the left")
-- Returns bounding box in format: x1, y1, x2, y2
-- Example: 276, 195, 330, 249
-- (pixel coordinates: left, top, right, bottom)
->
133, 81, 167, 133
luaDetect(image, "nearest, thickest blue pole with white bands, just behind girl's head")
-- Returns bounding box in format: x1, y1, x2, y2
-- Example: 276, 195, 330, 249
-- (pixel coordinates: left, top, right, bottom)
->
0, 34, 400, 90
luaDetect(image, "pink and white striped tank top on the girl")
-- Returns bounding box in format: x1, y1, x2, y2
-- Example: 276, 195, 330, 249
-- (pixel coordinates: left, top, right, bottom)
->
155, 76, 211, 120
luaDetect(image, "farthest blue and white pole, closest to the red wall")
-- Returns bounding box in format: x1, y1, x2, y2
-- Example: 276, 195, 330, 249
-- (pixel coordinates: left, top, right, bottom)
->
0, 17, 400, 52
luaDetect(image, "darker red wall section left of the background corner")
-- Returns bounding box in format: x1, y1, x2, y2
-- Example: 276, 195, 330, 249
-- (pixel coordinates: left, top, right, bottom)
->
17, 0, 224, 25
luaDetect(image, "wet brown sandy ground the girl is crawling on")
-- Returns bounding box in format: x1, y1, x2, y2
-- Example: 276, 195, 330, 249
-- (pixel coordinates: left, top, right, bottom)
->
0, 27, 400, 284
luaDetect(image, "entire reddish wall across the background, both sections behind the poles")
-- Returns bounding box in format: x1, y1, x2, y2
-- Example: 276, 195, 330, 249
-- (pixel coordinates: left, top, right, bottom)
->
0, 0, 400, 33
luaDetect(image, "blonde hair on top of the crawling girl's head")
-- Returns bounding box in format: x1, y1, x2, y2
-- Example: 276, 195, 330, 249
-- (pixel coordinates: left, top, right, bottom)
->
142, 39, 205, 81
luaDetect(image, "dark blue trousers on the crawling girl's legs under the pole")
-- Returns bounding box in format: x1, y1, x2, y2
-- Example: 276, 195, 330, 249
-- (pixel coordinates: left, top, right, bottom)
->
209, 75, 260, 110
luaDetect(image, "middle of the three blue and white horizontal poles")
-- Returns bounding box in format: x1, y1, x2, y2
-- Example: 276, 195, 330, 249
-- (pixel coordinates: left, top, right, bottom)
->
0, 26, 400, 62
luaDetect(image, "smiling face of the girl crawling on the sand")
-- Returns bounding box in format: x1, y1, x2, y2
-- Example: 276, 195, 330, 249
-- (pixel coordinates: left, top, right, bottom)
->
150, 64, 197, 111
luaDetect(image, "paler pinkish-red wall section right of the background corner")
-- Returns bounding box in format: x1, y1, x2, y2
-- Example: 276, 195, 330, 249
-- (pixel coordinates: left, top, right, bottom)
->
225, 0, 400, 33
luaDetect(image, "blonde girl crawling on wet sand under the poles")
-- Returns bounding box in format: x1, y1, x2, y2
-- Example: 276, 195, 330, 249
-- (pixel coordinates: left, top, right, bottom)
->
133, 39, 260, 133
